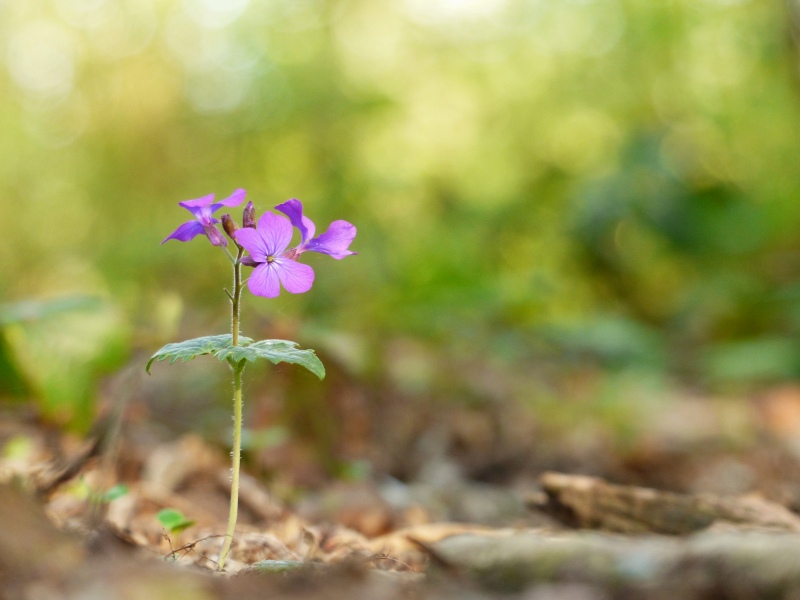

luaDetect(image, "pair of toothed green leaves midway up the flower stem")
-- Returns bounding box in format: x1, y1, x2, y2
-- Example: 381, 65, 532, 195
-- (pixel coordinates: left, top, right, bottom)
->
146, 334, 325, 379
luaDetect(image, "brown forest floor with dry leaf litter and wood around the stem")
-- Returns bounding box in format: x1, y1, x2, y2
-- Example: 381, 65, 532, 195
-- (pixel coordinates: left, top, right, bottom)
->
0, 370, 800, 600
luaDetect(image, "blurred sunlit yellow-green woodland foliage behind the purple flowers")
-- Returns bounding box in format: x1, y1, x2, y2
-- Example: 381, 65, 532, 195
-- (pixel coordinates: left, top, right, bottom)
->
0, 0, 800, 440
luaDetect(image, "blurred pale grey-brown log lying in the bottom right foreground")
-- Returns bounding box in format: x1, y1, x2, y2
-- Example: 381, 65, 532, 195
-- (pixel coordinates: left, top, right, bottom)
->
431, 531, 800, 599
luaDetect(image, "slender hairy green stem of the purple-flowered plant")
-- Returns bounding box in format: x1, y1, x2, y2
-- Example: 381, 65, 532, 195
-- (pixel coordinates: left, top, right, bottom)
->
217, 248, 245, 571
